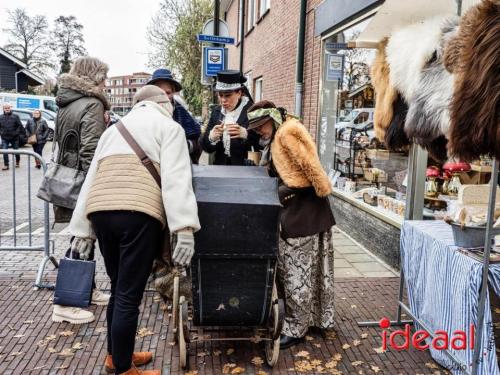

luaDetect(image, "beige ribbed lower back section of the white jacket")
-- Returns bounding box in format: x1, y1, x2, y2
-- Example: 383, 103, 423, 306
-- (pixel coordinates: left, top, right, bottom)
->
86, 155, 166, 227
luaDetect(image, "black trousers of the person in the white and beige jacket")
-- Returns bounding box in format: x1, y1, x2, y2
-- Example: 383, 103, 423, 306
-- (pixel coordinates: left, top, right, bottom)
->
89, 211, 163, 374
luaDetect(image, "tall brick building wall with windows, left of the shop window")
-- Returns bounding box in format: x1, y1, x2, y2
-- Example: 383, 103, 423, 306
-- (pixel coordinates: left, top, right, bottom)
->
223, 0, 322, 136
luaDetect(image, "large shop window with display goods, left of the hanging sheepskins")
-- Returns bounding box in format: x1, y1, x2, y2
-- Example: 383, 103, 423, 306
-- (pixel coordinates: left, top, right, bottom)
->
317, 16, 408, 223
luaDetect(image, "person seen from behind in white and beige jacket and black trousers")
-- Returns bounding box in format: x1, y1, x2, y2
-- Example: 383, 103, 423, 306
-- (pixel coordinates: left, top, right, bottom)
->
69, 85, 200, 375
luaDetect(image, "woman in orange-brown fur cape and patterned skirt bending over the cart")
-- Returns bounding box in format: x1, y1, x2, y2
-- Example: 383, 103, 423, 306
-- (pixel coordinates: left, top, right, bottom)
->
248, 101, 335, 348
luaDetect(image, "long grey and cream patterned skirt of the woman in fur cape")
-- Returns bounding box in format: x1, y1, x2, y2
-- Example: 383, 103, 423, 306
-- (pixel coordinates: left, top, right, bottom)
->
278, 229, 334, 337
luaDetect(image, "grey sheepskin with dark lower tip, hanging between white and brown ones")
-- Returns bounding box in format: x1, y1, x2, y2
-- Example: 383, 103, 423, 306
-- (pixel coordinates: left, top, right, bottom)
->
405, 17, 458, 162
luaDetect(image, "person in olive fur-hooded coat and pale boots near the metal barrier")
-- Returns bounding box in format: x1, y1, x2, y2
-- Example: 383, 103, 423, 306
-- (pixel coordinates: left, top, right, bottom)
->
52, 56, 109, 324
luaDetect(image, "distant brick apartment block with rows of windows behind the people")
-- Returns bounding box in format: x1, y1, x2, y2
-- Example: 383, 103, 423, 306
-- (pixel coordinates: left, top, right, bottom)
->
106, 72, 151, 115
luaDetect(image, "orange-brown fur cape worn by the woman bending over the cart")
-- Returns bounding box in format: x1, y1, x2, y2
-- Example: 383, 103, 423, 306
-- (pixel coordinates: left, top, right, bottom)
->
271, 118, 332, 197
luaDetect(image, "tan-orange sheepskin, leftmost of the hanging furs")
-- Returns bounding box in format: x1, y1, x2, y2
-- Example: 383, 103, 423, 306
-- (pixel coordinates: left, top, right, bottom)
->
370, 38, 398, 141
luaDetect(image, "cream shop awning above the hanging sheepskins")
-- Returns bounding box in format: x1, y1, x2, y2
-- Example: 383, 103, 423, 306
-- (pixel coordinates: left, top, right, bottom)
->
349, 0, 457, 48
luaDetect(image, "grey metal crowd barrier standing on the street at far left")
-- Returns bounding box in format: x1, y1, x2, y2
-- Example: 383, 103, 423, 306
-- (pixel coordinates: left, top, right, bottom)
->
0, 150, 59, 289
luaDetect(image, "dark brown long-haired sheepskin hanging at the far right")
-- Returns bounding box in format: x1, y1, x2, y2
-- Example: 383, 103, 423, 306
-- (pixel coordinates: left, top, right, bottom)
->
444, 0, 500, 161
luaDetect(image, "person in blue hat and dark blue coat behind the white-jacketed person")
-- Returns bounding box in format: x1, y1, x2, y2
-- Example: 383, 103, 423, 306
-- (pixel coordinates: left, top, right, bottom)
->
147, 69, 201, 164
